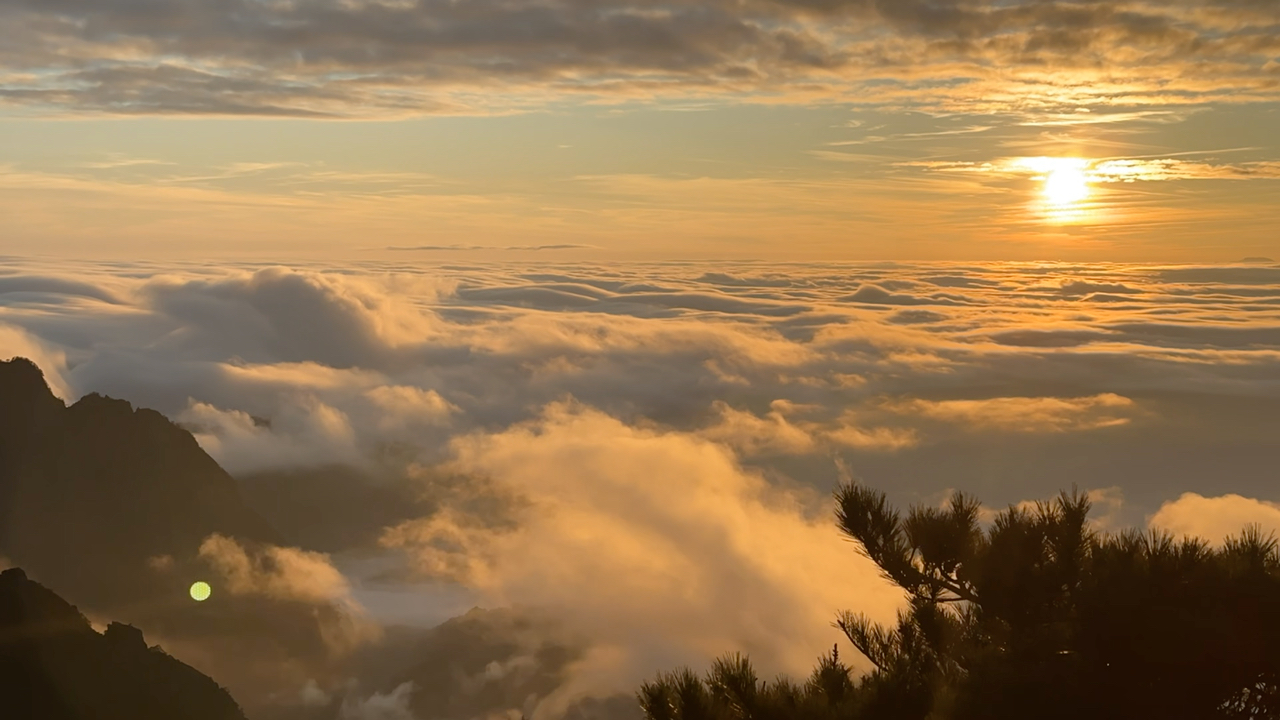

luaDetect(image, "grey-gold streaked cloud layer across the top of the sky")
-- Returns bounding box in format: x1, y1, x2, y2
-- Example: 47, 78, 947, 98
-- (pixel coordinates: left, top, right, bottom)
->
0, 0, 1280, 114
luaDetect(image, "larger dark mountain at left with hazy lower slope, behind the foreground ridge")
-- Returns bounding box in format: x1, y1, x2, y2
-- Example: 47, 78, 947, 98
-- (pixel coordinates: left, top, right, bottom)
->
0, 359, 343, 717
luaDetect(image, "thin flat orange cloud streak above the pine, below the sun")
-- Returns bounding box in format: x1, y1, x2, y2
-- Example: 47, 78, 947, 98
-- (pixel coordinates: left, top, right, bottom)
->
888, 393, 1134, 433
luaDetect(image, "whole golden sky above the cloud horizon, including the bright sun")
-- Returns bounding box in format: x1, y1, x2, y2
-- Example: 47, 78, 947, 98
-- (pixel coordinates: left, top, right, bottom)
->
0, 0, 1280, 257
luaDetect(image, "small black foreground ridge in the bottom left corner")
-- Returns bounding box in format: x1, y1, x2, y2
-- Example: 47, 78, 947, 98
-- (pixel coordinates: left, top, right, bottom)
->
0, 568, 244, 720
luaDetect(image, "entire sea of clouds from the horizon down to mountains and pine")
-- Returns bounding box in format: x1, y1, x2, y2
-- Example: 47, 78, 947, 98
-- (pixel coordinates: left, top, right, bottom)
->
0, 259, 1280, 717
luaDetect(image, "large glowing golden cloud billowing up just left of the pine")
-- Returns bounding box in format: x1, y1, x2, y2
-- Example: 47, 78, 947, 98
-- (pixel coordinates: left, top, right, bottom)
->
384, 404, 900, 717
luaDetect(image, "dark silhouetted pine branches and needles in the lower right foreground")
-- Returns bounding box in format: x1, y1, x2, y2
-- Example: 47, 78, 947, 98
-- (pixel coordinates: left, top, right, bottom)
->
640, 486, 1280, 720
